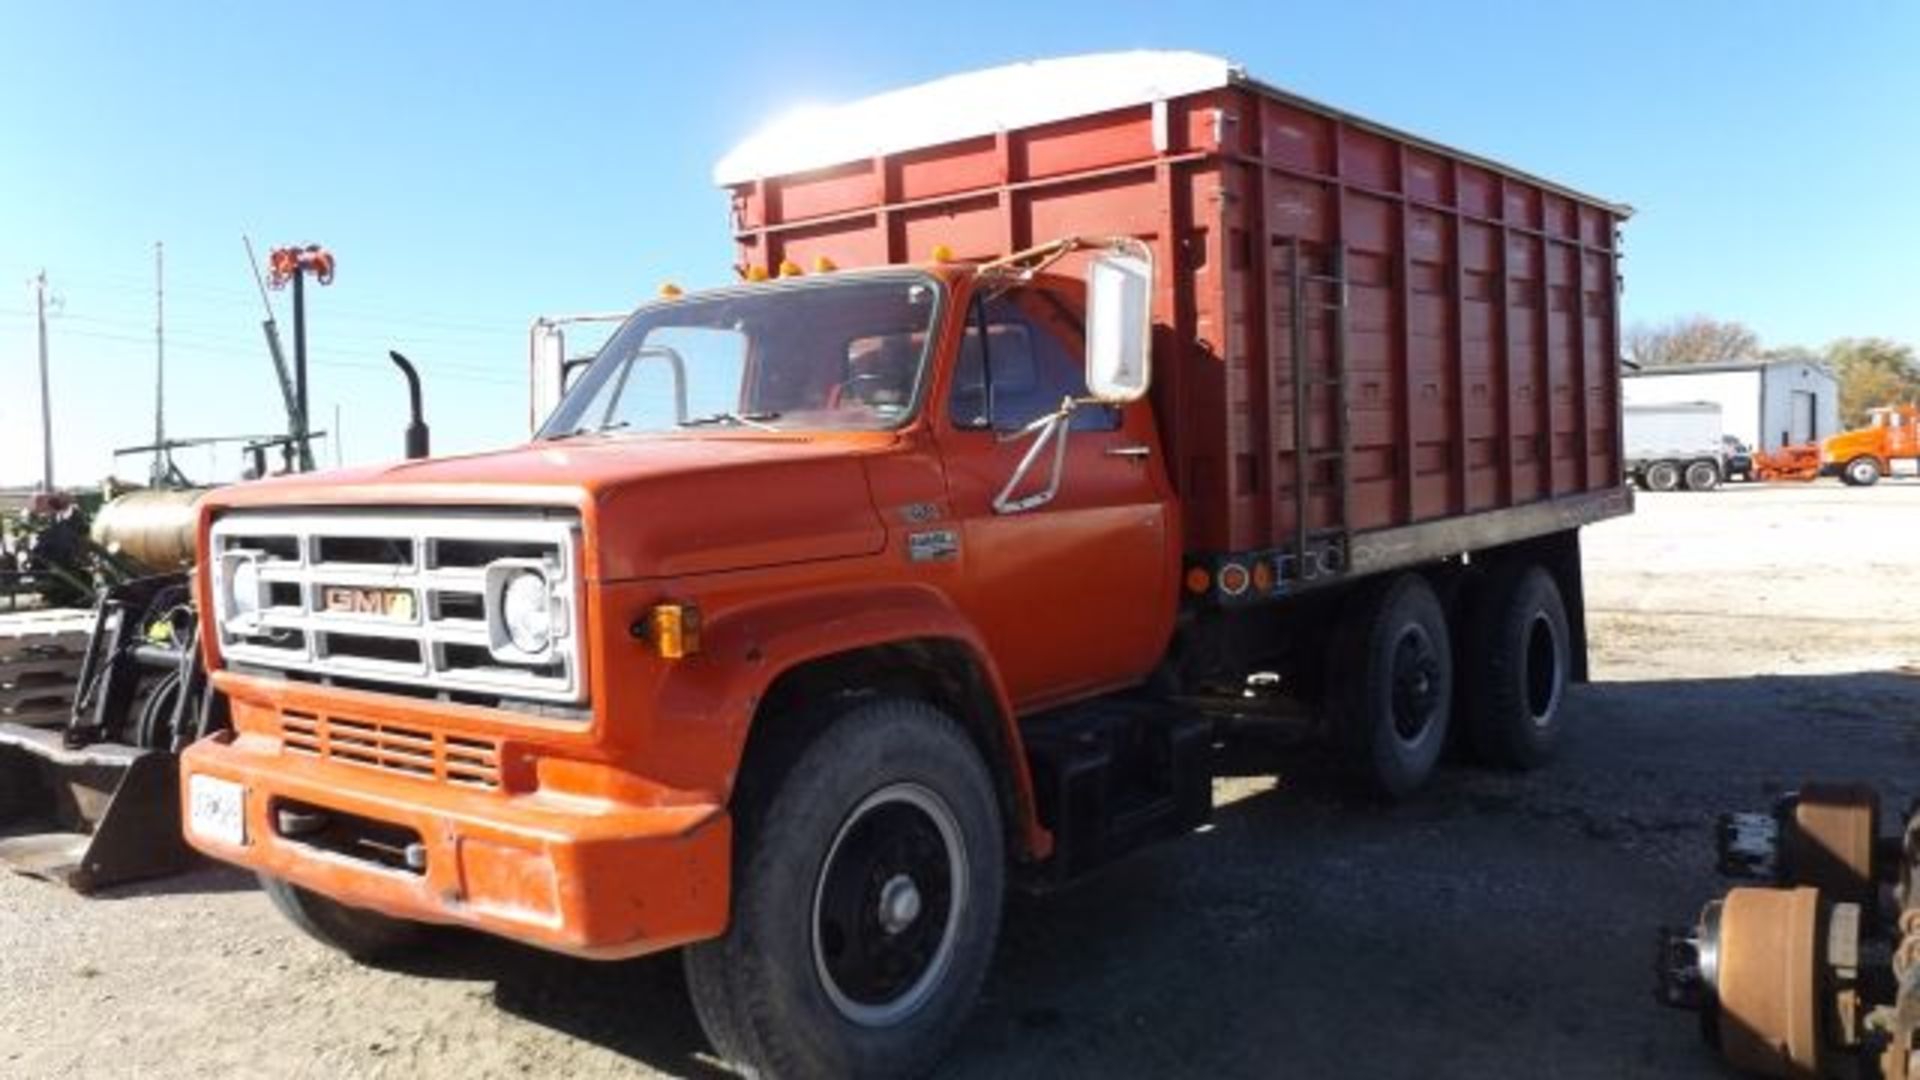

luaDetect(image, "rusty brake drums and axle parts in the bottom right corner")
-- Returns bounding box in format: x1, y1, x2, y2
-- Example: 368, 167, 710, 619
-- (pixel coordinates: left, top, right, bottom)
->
1657, 784, 1920, 1080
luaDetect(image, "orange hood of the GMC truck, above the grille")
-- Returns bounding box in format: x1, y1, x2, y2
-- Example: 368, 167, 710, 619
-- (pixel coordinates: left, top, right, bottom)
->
207, 432, 895, 580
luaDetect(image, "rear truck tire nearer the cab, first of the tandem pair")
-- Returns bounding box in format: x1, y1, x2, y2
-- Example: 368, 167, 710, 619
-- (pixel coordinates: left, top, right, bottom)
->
1327, 573, 1453, 799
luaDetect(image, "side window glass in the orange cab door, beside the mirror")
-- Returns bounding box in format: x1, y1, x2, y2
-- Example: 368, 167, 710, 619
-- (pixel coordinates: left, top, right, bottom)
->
948, 288, 1119, 432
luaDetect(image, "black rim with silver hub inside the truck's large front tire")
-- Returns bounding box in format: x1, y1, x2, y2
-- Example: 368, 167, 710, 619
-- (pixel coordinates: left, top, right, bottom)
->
812, 784, 968, 1026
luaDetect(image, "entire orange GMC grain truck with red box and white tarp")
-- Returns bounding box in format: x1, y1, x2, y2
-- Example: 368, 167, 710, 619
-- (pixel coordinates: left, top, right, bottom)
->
182, 54, 1632, 1076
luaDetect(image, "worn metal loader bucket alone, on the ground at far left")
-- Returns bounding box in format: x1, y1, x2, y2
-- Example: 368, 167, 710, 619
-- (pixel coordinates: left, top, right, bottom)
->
0, 723, 198, 892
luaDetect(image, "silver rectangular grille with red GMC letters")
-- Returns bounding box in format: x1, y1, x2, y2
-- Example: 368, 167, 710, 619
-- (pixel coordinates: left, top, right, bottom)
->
209, 511, 586, 703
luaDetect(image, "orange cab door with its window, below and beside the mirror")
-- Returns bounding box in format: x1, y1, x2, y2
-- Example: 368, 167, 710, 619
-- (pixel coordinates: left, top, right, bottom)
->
933, 286, 1179, 709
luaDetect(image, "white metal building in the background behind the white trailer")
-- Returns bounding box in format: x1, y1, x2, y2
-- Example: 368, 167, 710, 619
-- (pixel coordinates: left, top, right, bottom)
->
1620, 359, 1839, 450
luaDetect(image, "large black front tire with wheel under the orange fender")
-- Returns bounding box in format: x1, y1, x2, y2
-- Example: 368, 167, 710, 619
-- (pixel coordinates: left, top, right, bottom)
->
685, 700, 1006, 1076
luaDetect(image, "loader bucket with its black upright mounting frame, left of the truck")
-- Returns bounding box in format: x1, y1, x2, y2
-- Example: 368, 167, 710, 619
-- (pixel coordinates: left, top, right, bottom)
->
0, 575, 225, 892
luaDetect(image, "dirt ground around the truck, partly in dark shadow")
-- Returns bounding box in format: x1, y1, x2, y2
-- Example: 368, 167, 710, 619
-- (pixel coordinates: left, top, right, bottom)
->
0, 482, 1920, 1078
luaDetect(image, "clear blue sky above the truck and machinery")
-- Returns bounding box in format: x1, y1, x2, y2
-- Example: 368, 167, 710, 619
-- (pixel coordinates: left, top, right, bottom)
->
0, 0, 1920, 482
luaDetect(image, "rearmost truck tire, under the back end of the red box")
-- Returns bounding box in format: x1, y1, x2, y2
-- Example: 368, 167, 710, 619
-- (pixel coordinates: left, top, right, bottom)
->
1463, 563, 1572, 769
